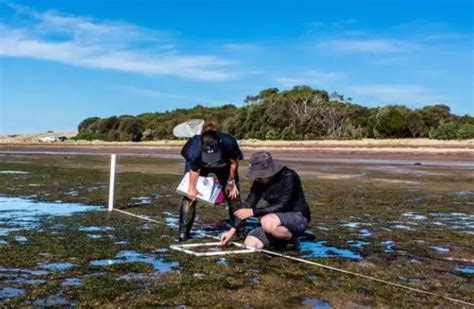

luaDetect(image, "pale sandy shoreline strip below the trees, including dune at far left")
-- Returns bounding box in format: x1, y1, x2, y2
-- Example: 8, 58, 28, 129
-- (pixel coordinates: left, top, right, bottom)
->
0, 132, 474, 165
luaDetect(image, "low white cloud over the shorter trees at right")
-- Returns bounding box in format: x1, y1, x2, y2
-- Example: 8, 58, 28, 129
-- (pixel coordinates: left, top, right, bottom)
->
349, 84, 448, 107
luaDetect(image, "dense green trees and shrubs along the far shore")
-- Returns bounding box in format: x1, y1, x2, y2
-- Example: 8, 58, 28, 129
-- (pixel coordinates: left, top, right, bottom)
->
76, 86, 474, 141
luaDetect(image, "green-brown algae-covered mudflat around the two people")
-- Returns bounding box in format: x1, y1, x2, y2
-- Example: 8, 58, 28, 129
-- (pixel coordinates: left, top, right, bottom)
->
0, 155, 474, 307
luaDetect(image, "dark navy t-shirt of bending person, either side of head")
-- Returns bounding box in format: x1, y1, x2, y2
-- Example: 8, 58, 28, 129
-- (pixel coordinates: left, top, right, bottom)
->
181, 132, 244, 172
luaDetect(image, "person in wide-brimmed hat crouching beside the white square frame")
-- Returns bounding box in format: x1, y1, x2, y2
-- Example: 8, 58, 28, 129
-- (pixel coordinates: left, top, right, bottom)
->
221, 151, 311, 249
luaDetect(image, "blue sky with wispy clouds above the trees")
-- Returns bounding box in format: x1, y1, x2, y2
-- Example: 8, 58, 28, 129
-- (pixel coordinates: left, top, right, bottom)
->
0, 0, 474, 134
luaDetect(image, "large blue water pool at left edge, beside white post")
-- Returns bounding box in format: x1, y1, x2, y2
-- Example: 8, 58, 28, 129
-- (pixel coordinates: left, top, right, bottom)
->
0, 196, 104, 236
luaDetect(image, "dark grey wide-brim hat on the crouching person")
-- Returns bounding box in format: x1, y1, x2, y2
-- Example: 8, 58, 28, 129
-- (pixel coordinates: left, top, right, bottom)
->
245, 151, 284, 179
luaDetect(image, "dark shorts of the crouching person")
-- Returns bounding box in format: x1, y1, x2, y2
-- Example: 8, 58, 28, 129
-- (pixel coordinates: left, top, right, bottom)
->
248, 212, 308, 247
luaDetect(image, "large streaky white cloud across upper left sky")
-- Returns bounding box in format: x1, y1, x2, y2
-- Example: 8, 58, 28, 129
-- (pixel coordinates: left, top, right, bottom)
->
0, 5, 234, 81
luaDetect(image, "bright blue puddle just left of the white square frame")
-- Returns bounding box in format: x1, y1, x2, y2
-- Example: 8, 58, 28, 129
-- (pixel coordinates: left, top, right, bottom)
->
90, 251, 179, 273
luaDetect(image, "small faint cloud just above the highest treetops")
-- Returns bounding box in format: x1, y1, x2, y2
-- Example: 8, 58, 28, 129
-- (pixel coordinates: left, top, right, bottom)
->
275, 70, 346, 88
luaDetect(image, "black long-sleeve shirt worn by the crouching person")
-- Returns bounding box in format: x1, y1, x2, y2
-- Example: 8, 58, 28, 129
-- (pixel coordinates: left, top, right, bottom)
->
244, 167, 311, 221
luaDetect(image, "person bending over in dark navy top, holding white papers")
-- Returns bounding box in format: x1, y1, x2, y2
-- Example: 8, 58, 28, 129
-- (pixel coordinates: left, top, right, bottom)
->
178, 122, 243, 241
